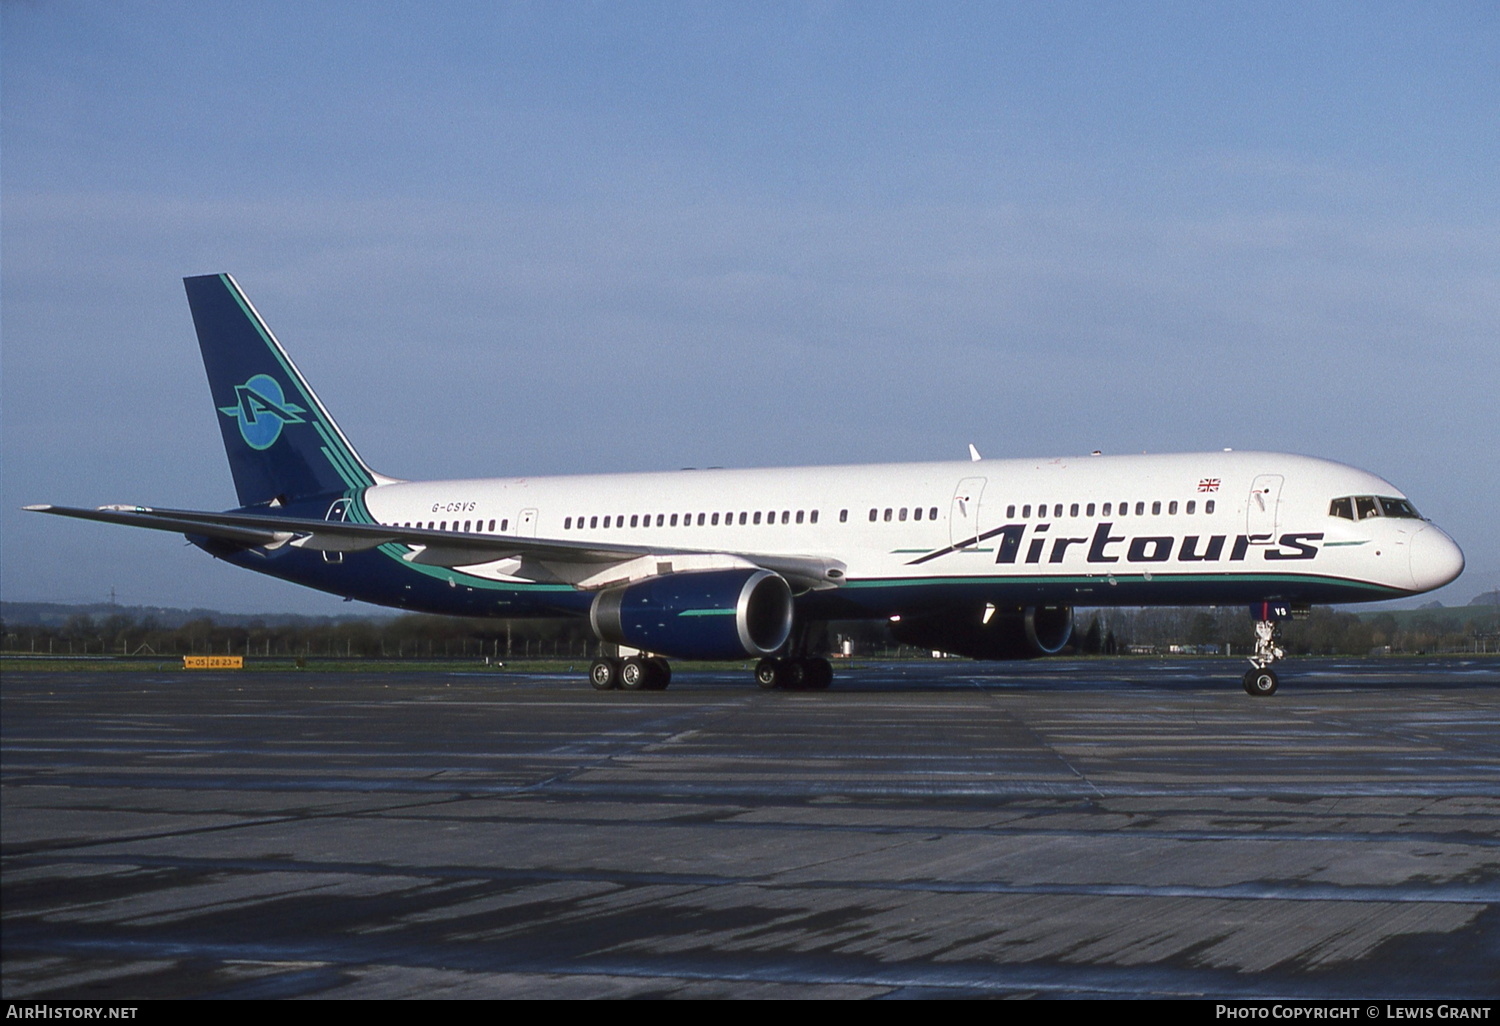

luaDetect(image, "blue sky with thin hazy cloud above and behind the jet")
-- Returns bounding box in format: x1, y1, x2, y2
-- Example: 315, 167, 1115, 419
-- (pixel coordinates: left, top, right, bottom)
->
0, 0, 1500, 612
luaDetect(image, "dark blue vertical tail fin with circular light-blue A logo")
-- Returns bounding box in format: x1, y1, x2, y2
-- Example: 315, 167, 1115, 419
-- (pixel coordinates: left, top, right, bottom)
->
183, 275, 377, 506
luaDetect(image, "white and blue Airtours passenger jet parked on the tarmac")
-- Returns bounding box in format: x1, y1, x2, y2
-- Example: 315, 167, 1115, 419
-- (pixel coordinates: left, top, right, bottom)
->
27, 275, 1464, 695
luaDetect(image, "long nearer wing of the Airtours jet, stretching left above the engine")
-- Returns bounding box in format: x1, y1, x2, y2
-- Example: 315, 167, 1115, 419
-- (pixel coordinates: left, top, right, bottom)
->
23, 504, 845, 588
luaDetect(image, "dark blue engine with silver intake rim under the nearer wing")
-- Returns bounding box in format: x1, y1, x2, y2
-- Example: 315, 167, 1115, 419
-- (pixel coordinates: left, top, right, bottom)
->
588, 570, 792, 659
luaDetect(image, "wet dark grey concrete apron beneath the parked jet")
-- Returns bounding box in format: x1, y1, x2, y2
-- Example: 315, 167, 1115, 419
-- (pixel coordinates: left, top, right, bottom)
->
0, 659, 1500, 999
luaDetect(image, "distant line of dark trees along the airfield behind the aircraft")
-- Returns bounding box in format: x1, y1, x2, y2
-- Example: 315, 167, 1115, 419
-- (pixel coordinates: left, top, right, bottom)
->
0, 606, 1500, 660
